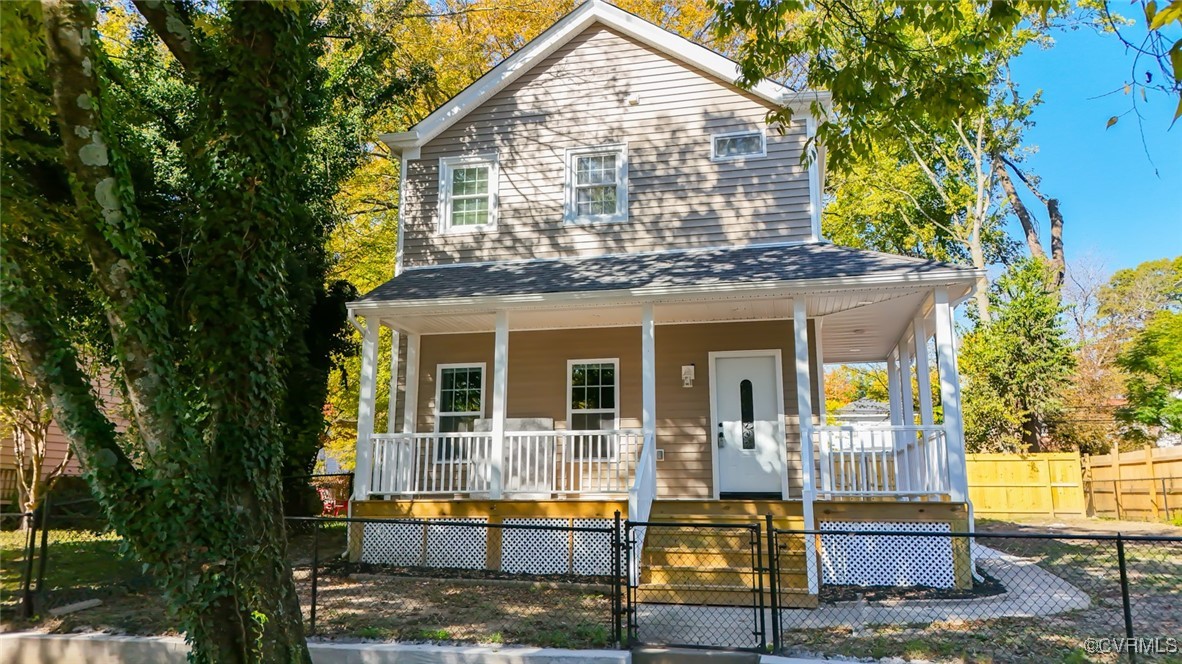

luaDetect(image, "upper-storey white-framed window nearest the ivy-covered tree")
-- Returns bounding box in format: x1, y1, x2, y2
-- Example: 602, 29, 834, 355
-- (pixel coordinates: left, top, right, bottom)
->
440, 155, 498, 233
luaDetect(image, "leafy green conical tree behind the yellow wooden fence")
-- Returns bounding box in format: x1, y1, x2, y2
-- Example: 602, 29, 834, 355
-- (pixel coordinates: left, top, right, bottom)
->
960, 259, 1074, 451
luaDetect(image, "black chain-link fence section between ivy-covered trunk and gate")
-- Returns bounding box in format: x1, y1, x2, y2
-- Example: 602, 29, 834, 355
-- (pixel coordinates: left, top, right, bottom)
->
287, 514, 625, 647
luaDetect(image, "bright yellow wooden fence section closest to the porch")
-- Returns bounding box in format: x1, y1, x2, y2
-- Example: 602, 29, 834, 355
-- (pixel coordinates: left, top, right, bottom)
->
966, 451, 1087, 519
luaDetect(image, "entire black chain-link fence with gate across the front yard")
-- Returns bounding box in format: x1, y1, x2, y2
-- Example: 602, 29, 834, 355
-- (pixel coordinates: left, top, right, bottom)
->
0, 506, 1182, 662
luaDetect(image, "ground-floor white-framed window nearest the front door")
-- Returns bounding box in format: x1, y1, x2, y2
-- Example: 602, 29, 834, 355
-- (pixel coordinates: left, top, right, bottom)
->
566, 359, 619, 458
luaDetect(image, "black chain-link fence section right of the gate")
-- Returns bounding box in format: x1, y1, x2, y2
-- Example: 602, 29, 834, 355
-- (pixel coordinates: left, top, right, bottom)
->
772, 530, 1182, 662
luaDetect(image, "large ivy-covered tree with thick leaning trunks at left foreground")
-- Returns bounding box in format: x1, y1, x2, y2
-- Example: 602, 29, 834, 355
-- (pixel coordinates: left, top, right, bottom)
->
0, 0, 421, 663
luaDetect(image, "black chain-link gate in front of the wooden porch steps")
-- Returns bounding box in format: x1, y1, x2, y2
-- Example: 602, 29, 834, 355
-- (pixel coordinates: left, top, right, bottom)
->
624, 521, 769, 650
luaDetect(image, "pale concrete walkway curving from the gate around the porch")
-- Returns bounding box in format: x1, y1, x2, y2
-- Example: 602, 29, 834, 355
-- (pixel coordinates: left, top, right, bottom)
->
637, 546, 1091, 647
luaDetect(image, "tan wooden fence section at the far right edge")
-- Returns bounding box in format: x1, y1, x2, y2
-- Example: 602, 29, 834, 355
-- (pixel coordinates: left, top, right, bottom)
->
1084, 445, 1182, 521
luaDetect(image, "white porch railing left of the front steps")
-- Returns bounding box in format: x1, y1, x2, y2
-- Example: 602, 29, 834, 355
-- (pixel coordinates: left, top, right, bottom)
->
370, 429, 643, 496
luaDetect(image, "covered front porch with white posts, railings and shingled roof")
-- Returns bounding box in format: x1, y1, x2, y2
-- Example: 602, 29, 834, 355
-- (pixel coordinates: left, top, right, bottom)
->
350, 246, 976, 517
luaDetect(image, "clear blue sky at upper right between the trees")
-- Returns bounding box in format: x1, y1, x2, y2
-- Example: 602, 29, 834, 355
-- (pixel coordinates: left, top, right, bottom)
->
1013, 22, 1182, 273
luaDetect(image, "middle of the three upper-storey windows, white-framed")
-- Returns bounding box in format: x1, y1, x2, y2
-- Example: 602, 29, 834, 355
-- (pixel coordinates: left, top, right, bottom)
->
566, 145, 628, 223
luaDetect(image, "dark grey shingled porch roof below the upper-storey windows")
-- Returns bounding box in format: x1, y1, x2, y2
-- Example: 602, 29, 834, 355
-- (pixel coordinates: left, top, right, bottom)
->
361, 243, 972, 302
